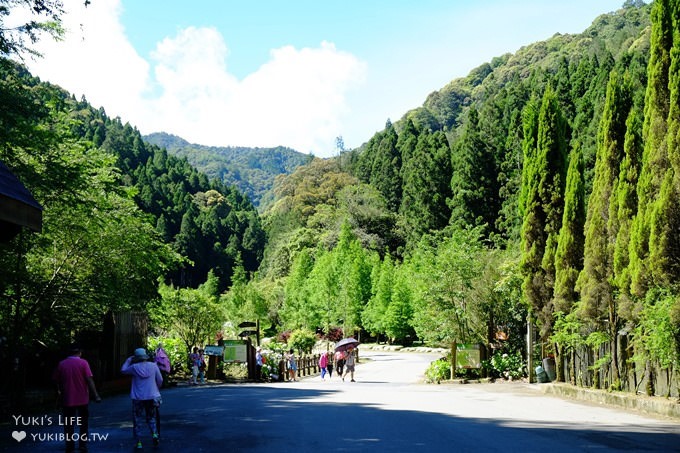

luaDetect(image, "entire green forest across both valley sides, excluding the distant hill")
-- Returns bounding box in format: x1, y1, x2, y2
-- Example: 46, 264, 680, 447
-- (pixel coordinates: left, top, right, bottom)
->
0, 0, 680, 395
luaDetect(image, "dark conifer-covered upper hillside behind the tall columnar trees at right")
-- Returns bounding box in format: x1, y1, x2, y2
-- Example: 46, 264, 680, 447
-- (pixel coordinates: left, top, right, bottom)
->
349, 2, 650, 247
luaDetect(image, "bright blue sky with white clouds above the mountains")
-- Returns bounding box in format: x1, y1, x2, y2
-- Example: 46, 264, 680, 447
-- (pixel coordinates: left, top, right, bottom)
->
19, 0, 623, 157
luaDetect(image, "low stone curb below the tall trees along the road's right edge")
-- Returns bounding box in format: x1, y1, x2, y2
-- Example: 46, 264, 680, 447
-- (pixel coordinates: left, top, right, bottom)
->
538, 383, 680, 420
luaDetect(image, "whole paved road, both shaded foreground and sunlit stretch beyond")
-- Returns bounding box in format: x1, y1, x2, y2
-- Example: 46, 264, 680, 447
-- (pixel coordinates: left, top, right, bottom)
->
5, 351, 680, 453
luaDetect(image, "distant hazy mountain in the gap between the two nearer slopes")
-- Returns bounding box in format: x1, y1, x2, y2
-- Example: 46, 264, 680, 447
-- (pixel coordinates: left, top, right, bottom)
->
144, 132, 311, 207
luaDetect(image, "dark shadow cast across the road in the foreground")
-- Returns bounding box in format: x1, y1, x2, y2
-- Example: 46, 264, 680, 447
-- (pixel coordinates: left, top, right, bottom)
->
0, 382, 680, 453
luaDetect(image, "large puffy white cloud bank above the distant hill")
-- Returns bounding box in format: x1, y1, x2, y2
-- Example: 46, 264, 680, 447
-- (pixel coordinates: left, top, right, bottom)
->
22, 0, 367, 156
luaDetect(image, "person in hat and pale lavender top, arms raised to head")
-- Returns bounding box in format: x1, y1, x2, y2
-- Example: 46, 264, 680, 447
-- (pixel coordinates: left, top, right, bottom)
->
120, 348, 163, 450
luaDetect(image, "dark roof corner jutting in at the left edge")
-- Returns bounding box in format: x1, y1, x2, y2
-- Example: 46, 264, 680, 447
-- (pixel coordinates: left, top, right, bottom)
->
0, 162, 42, 240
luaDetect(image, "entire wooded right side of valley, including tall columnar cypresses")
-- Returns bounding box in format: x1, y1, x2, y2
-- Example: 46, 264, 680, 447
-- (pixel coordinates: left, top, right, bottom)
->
254, 0, 680, 394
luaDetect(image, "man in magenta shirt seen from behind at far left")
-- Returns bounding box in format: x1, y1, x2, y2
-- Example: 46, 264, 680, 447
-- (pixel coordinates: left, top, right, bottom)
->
52, 345, 101, 452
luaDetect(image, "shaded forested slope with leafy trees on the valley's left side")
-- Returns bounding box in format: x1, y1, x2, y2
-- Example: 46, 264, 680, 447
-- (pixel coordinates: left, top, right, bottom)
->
0, 59, 265, 351
